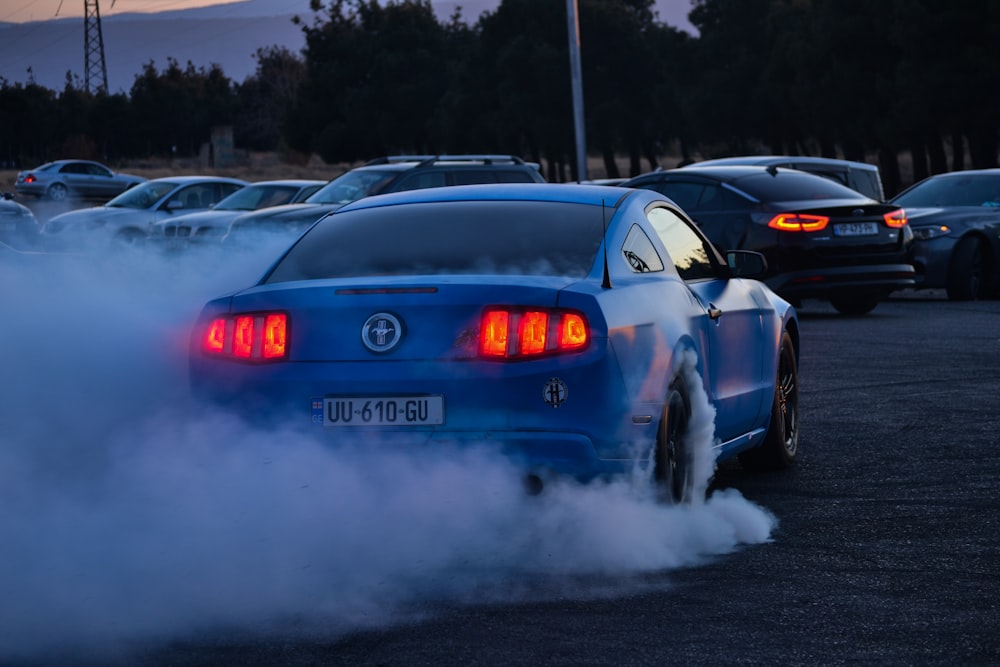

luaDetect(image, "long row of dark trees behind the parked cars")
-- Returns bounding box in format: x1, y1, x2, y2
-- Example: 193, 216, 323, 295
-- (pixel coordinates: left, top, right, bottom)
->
0, 0, 1000, 193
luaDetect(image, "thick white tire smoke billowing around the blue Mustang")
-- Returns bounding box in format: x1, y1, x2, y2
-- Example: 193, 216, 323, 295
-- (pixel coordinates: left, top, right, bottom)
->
0, 244, 776, 661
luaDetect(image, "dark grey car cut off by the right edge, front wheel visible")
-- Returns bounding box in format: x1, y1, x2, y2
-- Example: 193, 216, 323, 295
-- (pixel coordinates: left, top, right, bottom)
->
890, 169, 1000, 300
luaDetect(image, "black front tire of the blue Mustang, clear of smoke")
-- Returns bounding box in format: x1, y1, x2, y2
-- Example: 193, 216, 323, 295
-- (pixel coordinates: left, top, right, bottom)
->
739, 331, 799, 470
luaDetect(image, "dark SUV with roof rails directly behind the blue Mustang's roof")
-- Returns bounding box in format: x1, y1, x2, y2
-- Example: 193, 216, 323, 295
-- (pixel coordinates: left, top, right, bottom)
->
223, 155, 545, 247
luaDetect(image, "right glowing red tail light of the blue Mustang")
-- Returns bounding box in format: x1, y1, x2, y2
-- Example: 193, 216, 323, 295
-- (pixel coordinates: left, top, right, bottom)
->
479, 307, 590, 360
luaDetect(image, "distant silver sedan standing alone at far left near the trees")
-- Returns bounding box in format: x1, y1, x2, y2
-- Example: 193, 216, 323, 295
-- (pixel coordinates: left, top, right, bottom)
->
14, 160, 147, 201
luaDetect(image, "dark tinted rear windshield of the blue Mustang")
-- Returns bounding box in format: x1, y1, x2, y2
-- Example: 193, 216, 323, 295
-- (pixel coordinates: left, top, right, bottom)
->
263, 201, 604, 283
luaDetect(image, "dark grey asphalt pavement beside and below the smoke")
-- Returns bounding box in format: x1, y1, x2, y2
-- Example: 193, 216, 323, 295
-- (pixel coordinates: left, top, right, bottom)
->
127, 292, 1000, 665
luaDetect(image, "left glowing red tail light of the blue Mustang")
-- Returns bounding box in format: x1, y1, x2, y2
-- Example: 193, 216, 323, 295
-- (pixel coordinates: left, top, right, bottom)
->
201, 313, 288, 361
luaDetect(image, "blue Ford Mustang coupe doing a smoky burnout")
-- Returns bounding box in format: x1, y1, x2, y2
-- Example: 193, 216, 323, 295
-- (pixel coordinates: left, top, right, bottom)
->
191, 184, 799, 501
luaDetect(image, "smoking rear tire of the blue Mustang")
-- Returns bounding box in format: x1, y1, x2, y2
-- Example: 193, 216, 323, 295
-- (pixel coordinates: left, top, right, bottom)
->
653, 379, 694, 504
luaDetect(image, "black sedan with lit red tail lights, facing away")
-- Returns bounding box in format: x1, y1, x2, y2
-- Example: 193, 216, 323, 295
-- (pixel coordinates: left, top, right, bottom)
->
624, 166, 915, 314
